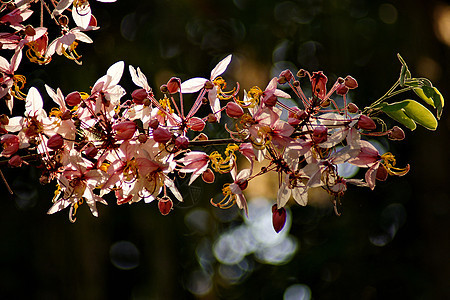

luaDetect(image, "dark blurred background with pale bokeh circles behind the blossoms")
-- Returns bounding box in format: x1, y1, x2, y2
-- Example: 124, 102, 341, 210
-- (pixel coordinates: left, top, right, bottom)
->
0, 0, 450, 300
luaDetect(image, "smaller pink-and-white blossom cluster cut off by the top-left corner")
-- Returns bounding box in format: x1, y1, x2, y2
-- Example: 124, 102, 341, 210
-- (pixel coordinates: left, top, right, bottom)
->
0, 0, 116, 111
